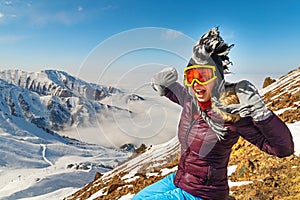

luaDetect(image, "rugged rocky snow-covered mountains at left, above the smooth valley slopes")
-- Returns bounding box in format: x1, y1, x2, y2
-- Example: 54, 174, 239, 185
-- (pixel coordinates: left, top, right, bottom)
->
0, 70, 127, 130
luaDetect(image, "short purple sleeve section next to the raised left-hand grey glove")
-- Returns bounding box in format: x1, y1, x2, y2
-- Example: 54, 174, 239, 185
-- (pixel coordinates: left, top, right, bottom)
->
165, 82, 189, 106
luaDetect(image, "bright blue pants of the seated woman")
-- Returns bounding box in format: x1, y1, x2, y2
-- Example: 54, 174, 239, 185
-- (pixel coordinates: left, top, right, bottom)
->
132, 173, 202, 200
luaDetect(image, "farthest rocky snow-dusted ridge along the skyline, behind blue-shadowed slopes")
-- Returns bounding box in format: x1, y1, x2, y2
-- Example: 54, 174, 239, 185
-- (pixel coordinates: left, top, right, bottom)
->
0, 70, 122, 101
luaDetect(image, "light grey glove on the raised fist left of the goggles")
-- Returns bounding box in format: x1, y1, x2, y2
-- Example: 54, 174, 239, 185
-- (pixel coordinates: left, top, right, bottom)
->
151, 67, 178, 96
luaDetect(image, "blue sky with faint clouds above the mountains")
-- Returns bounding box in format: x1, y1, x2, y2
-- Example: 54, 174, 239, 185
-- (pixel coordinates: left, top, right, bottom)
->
0, 0, 300, 85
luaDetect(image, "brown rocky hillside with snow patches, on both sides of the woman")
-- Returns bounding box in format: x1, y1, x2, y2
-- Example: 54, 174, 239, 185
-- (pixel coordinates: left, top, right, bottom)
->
65, 68, 300, 200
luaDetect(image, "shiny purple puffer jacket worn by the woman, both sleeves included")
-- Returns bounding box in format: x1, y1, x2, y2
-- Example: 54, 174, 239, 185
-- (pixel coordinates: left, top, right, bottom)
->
165, 83, 294, 200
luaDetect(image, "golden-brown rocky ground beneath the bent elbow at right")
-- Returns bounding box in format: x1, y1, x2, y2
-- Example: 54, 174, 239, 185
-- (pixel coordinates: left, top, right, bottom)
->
229, 139, 300, 200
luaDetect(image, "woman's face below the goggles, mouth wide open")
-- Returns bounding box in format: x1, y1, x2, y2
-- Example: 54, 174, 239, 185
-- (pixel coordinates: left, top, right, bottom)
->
192, 80, 216, 102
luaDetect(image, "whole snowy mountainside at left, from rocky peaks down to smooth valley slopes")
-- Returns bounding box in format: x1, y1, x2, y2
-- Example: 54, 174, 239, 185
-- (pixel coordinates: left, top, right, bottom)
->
0, 70, 148, 199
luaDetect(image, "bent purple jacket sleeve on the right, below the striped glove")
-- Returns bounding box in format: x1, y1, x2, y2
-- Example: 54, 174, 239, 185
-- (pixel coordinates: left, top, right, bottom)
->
238, 114, 294, 158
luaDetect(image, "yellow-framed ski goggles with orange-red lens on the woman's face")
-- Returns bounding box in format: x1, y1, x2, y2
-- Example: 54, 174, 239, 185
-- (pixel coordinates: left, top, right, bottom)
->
184, 65, 217, 86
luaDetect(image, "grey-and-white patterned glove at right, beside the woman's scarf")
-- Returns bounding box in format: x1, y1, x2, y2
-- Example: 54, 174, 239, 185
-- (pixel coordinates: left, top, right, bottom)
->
213, 80, 272, 121
